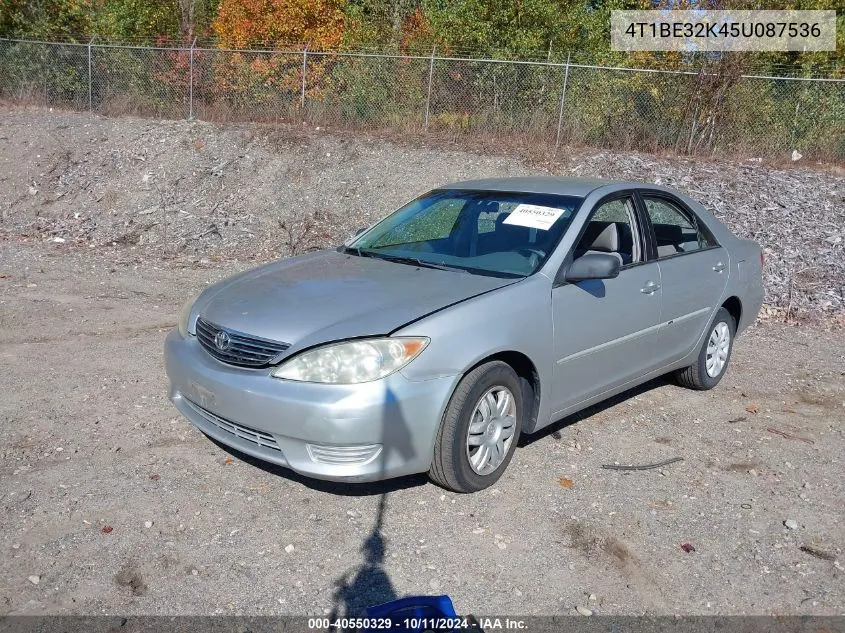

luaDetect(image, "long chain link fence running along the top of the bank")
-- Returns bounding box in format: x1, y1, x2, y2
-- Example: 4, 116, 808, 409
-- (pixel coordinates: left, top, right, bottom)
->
0, 38, 845, 161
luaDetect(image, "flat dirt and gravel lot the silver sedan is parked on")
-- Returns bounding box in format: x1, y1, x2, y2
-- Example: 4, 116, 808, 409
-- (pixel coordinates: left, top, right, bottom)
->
0, 239, 845, 615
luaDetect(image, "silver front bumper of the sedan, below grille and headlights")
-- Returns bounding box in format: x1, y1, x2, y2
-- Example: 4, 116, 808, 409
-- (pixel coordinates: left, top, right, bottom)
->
164, 330, 457, 482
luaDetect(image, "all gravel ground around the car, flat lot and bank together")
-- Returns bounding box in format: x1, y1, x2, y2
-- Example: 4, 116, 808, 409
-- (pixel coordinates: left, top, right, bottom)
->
0, 106, 845, 615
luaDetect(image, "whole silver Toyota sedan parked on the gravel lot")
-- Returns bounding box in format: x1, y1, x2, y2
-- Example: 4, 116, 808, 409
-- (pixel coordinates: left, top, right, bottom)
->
165, 178, 763, 492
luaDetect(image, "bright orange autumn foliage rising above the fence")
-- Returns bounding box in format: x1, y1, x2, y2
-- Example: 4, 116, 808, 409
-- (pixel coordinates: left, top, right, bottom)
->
213, 0, 346, 50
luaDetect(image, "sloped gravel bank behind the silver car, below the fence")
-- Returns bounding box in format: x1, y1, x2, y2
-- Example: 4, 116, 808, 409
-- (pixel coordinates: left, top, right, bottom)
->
0, 105, 845, 323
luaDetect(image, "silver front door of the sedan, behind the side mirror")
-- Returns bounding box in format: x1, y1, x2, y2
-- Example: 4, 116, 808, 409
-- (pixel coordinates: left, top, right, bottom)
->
552, 194, 662, 413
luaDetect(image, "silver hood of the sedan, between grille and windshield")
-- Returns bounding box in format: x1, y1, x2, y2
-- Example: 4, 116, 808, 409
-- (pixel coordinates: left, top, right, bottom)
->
192, 251, 519, 351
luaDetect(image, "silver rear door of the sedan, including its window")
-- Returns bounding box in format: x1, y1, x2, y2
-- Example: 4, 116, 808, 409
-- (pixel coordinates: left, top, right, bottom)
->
639, 191, 730, 365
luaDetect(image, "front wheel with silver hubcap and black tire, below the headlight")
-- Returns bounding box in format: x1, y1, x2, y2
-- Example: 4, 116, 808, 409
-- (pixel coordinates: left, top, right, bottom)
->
429, 361, 523, 493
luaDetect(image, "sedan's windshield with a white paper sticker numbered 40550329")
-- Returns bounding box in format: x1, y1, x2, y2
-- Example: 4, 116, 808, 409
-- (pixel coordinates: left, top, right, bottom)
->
345, 189, 582, 277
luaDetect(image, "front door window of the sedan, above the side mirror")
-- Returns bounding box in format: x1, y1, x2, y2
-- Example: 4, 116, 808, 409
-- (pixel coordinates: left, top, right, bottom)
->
575, 196, 643, 266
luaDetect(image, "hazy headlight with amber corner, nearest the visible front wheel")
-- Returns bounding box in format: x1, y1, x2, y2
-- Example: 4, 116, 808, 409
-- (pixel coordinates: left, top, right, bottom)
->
273, 337, 429, 385
